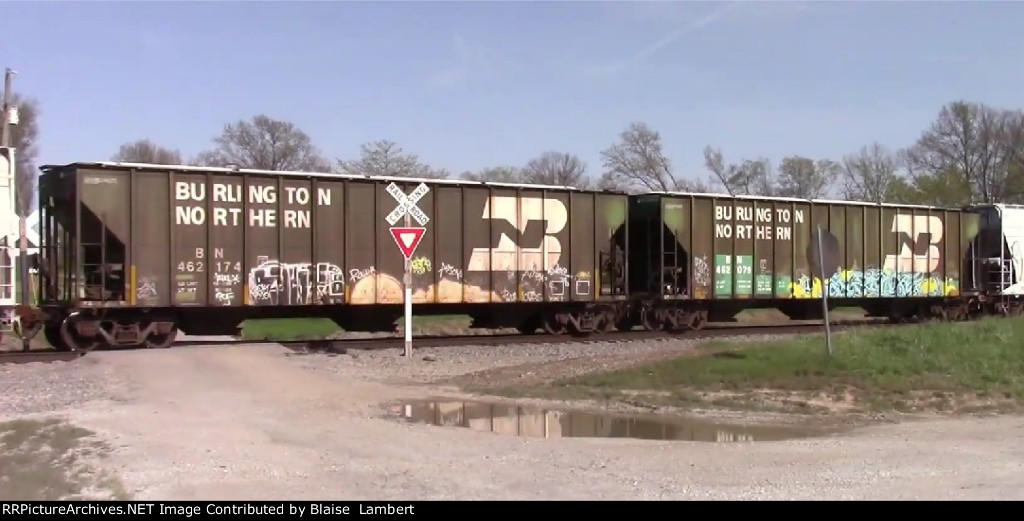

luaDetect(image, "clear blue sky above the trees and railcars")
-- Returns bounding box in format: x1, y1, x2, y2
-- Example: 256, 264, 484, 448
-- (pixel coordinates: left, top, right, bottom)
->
6, 1, 1024, 185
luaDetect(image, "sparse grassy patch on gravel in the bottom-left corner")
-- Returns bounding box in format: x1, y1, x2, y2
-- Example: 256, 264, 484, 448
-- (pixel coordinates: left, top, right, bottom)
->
0, 420, 129, 501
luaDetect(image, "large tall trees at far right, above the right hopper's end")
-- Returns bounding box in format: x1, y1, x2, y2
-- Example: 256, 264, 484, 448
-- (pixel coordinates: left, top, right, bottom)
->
905, 100, 1024, 205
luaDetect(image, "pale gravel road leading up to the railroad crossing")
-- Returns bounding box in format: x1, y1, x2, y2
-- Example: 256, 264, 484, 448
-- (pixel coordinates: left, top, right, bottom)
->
0, 341, 1024, 500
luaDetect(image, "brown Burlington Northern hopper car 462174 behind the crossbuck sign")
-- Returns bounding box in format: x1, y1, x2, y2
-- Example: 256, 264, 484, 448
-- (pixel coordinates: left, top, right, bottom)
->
29, 163, 628, 350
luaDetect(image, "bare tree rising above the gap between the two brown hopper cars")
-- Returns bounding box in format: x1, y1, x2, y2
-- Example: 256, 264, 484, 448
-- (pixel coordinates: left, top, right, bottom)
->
601, 123, 684, 191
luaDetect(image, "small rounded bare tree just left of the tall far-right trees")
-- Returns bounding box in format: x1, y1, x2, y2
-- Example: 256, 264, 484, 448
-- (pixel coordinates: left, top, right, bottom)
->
842, 143, 908, 203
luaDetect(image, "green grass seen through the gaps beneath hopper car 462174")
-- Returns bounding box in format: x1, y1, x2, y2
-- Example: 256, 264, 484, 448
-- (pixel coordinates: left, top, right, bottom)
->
242, 315, 470, 341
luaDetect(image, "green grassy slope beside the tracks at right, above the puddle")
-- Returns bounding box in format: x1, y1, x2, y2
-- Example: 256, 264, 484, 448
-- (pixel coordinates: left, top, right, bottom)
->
502, 318, 1024, 410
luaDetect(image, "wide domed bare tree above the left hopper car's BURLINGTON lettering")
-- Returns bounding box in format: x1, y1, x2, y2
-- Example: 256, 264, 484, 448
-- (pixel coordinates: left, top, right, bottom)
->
196, 114, 331, 172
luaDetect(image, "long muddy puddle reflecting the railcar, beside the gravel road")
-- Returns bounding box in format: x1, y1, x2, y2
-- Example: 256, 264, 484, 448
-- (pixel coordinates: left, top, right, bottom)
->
394, 400, 822, 442
